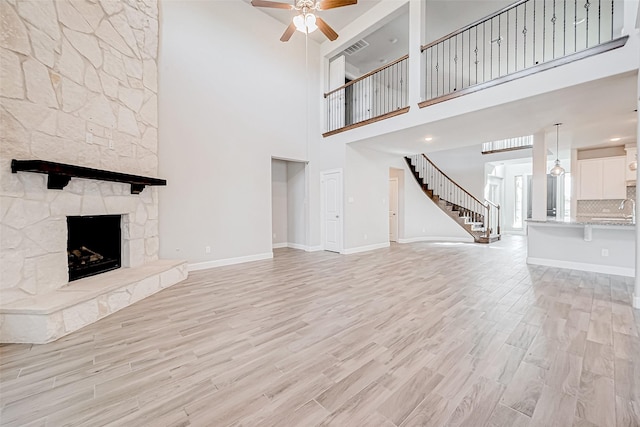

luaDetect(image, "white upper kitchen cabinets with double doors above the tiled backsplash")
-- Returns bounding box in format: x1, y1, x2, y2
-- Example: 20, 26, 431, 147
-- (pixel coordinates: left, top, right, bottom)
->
578, 156, 627, 200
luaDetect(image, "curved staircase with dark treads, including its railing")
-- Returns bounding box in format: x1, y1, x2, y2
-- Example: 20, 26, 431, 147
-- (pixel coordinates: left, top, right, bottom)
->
405, 154, 500, 243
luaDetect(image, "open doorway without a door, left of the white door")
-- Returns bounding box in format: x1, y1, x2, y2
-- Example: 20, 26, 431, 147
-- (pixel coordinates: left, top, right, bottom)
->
271, 158, 307, 254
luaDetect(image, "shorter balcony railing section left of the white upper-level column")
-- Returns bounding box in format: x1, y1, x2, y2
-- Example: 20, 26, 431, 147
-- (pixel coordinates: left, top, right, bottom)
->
324, 55, 409, 136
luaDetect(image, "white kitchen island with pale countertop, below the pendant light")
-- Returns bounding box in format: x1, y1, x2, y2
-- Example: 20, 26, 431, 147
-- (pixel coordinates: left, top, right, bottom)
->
527, 219, 636, 277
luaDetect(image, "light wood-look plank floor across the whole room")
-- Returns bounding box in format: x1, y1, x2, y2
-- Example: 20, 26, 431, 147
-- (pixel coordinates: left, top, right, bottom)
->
0, 237, 640, 427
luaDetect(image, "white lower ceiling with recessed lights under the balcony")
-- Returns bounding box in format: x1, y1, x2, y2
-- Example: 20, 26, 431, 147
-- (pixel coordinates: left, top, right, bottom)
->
355, 72, 638, 161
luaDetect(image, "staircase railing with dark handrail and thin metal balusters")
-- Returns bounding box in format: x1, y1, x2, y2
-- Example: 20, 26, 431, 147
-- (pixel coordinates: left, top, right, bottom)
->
409, 154, 500, 238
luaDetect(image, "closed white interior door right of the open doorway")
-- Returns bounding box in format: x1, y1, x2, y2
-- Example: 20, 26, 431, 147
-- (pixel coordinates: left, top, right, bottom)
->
320, 170, 342, 252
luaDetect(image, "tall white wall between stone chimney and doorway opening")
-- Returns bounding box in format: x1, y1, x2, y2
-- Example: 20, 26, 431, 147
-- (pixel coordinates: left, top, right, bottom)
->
159, 0, 322, 267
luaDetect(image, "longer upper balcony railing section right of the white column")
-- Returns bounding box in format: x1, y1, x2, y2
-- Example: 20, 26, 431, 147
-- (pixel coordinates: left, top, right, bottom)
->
420, 0, 626, 107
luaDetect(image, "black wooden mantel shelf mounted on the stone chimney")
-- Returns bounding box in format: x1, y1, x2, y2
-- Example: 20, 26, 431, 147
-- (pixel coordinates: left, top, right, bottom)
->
11, 159, 167, 194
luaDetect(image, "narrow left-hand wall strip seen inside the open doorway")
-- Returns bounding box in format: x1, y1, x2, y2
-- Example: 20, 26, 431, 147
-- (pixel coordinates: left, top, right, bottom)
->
271, 159, 289, 246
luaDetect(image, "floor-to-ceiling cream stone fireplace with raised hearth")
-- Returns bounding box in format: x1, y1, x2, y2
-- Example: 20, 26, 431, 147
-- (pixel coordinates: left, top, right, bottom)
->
0, 0, 186, 343
